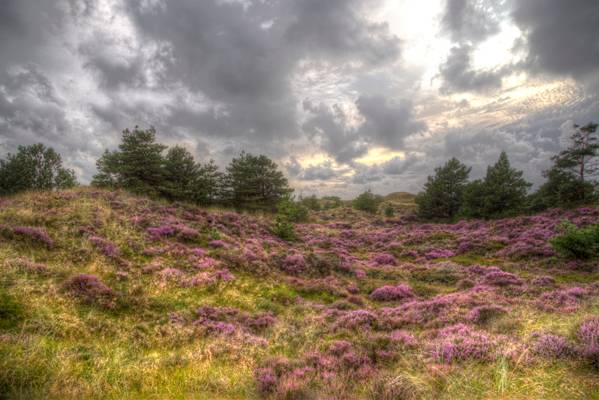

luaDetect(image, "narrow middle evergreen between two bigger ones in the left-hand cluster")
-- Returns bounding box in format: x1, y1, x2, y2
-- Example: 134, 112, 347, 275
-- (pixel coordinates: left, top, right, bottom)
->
162, 146, 199, 201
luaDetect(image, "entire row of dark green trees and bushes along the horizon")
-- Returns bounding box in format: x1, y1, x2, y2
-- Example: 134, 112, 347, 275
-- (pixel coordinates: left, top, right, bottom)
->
0, 122, 599, 225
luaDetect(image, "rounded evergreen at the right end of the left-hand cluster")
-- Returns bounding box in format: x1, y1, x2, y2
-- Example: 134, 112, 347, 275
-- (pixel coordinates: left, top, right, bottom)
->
225, 152, 292, 210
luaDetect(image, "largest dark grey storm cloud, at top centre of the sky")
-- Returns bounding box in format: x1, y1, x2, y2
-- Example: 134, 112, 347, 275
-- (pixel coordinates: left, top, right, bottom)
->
118, 0, 399, 142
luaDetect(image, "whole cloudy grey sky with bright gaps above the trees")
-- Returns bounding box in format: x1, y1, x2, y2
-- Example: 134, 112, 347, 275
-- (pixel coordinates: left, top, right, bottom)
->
0, 0, 599, 198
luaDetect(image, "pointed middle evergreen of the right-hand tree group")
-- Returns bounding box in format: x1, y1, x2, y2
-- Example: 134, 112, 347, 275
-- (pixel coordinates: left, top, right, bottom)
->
462, 152, 531, 218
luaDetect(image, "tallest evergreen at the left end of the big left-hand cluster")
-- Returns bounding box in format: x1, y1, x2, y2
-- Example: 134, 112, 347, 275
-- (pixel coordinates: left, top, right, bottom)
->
92, 126, 166, 196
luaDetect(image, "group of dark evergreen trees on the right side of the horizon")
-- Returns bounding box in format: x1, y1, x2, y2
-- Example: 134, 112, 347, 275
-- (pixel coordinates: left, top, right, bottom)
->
416, 122, 599, 221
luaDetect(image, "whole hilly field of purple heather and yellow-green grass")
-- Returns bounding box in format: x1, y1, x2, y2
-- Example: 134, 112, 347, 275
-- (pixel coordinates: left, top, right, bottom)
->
0, 188, 599, 400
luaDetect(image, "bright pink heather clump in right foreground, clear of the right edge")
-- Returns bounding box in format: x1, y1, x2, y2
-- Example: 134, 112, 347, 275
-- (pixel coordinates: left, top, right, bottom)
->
429, 324, 497, 364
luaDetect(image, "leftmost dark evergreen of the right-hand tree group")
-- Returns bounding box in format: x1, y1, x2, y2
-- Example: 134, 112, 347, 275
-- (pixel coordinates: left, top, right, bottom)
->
415, 158, 470, 220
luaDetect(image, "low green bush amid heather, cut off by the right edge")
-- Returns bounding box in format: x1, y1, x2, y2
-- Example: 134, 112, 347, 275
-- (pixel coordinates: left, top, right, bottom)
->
551, 221, 599, 260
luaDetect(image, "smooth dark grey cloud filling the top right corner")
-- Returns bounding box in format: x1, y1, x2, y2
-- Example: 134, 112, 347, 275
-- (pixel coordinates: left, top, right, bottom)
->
513, 0, 599, 78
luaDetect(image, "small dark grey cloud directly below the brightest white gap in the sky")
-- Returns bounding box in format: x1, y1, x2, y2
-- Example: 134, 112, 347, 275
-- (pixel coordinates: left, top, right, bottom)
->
440, 45, 509, 93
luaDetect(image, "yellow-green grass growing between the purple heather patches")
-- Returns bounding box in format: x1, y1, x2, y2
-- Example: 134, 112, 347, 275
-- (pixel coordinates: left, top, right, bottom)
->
0, 189, 599, 399
